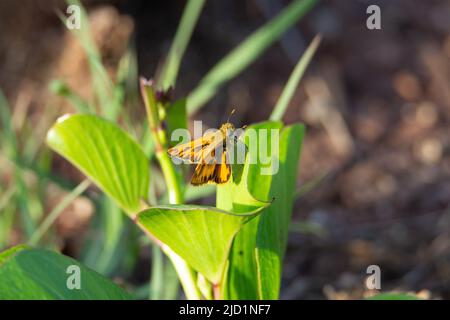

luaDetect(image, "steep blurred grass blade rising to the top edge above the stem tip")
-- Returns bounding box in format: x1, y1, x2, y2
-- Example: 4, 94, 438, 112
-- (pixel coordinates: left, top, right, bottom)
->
159, 0, 205, 89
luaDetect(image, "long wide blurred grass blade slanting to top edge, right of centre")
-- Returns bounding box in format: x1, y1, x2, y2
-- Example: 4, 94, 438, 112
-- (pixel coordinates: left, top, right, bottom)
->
187, 0, 317, 114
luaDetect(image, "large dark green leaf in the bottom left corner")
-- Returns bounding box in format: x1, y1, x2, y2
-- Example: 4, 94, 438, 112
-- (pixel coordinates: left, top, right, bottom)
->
0, 246, 131, 300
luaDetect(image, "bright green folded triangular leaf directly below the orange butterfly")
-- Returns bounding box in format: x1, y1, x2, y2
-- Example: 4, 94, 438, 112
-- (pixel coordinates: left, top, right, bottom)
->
137, 202, 267, 284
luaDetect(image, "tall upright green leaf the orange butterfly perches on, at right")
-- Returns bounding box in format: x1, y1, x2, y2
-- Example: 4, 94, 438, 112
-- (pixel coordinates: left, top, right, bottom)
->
217, 122, 304, 299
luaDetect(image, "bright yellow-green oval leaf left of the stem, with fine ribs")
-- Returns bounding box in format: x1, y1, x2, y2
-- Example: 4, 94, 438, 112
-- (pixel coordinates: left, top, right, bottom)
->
47, 114, 149, 214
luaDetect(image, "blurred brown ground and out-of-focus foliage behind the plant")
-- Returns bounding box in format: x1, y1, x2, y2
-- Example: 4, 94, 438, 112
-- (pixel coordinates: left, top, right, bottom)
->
0, 0, 450, 299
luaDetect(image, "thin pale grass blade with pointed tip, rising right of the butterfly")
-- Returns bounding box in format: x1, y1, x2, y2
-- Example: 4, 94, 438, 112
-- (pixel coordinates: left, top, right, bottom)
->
269, 36, 321, 121
